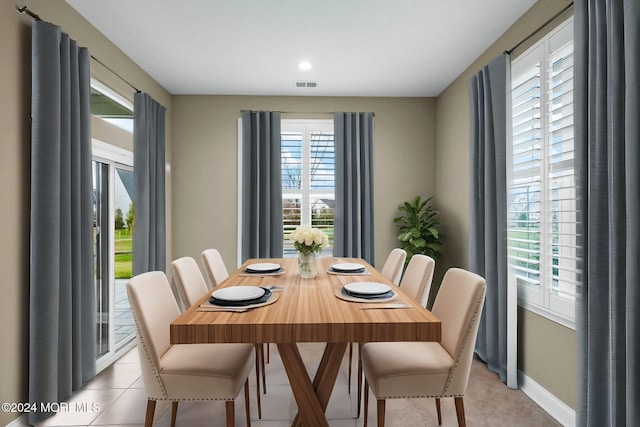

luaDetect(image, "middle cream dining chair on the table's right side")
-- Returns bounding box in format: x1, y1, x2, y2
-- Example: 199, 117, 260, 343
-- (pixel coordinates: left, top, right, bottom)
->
356, 254, 436, 417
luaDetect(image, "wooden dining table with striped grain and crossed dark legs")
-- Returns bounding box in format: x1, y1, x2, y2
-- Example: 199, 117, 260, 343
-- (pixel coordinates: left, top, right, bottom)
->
170, 256, 441, 426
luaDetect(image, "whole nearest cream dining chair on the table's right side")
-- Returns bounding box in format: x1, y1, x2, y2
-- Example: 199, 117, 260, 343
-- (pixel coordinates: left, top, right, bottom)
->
361, 268, 487, 426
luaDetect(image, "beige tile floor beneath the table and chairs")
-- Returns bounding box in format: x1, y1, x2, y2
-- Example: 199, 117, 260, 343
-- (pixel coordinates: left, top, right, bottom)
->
22, 344, 560, 427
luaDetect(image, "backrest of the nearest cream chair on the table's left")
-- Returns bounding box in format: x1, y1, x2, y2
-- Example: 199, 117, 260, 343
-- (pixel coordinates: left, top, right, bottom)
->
127, 271, 180, 398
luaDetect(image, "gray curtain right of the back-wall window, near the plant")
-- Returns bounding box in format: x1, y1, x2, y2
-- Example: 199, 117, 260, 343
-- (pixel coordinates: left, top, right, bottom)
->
333, 112, 375, 264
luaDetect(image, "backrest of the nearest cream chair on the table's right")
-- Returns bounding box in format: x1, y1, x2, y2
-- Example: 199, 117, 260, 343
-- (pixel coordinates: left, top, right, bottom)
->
431, 268, 487, 396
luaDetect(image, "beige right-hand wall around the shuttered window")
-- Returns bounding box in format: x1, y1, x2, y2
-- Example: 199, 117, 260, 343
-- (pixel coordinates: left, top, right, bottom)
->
436, 0, 576, 408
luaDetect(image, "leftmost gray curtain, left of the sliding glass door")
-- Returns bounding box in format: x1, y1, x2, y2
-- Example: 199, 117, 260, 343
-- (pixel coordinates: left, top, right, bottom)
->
29, 21, 96, 424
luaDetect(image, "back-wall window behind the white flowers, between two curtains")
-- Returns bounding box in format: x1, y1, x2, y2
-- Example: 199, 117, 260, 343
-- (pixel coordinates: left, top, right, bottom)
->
281, 120, 336, 256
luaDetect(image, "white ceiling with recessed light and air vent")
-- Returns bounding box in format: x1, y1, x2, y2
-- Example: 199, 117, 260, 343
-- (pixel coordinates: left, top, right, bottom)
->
67, 0, 535, 97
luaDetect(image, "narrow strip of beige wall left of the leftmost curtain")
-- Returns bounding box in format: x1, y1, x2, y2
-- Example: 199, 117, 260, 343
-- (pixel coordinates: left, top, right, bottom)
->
0, 2, 31, 425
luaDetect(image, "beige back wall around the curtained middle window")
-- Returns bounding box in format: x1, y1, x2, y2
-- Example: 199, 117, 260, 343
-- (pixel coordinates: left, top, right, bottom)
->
172, 96, 435, 269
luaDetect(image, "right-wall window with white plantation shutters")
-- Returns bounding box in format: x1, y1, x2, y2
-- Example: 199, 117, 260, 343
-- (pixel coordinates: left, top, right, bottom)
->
507, 15, 578, 327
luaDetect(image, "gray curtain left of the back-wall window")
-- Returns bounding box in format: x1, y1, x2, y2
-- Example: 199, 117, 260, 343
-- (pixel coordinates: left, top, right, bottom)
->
241, 111, 284, 262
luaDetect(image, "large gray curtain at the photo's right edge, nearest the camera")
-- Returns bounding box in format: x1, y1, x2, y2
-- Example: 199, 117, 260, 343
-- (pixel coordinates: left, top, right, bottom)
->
574, 0, 640, 426
